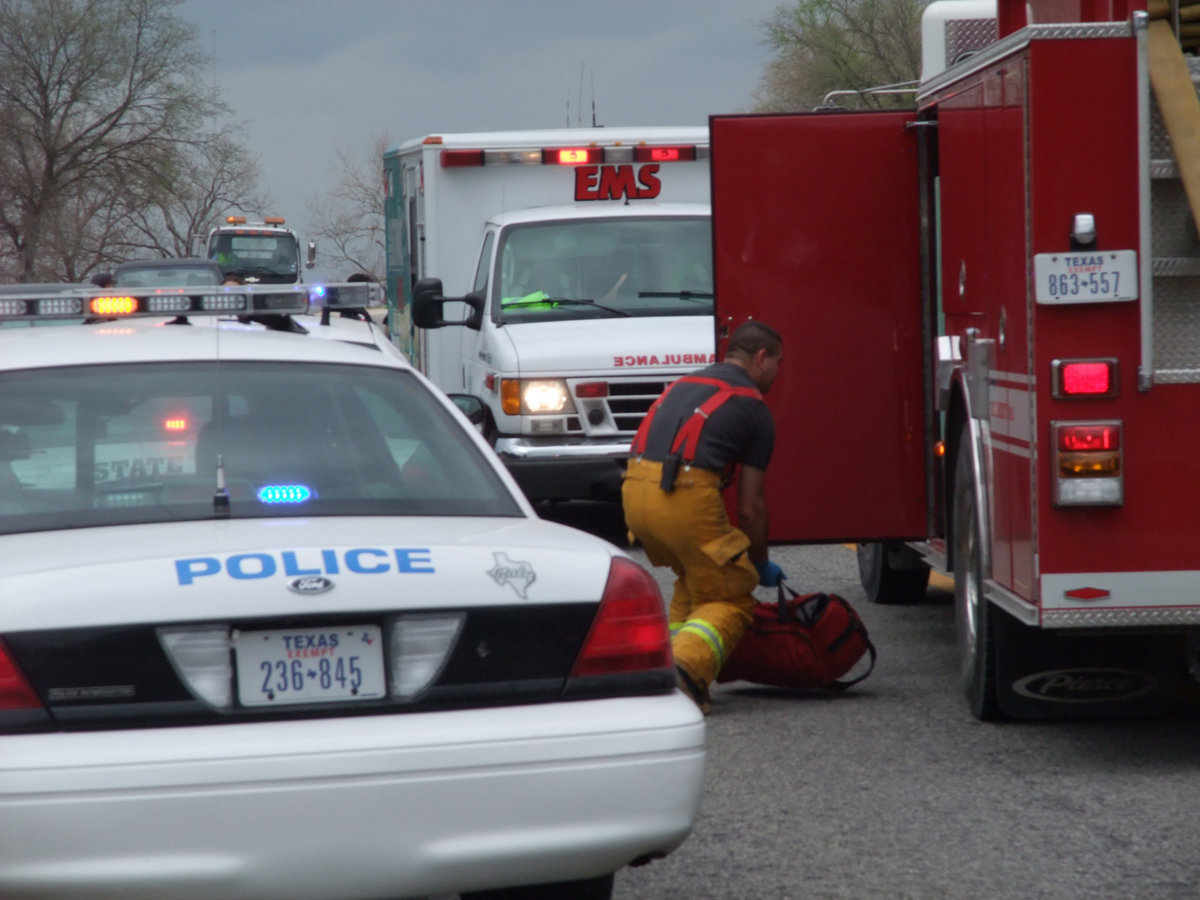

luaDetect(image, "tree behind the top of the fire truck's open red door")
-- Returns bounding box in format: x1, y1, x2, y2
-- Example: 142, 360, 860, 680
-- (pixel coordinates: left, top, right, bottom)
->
756, 0, 928, 112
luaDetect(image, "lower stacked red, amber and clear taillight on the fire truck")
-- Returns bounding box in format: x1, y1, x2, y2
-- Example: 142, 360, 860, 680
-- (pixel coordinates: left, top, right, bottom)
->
1050, 421, 1124, 506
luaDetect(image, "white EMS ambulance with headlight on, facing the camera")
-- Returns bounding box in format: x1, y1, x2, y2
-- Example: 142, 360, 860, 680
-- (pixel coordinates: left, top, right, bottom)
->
383, 127, 714, 500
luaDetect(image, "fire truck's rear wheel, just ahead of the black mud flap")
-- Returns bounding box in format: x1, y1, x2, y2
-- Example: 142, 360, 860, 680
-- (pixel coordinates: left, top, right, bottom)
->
954, 428, 1001, 721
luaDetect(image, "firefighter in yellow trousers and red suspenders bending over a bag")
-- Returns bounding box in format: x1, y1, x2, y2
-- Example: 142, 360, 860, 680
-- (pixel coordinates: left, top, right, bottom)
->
622, 320, 784, 713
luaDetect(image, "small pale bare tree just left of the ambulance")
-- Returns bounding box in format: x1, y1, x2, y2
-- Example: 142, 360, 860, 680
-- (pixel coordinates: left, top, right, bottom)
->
308, 133, 391, 281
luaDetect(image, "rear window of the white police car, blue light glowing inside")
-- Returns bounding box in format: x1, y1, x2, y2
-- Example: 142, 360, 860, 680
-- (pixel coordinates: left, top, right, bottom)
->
0, 362, 522, 534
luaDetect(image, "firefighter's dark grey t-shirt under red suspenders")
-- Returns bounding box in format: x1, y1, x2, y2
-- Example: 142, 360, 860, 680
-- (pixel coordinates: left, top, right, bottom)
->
642, 362, 775, 472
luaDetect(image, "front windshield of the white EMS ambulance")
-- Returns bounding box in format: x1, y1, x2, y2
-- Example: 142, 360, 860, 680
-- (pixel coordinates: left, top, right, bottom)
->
493, 217, 713, 323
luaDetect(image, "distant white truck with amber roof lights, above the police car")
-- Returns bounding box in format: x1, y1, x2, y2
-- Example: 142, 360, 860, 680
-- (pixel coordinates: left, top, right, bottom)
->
205, 216, 317, 284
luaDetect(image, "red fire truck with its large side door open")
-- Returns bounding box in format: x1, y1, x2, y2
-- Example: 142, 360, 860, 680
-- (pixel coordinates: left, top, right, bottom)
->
710, 0, 1200, 720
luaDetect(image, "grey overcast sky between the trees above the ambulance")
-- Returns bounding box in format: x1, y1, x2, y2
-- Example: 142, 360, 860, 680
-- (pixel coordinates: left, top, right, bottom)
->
180, 0, 782, 254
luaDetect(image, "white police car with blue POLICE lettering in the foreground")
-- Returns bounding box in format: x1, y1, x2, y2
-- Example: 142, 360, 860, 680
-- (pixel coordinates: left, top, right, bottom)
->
0, 286, 704, 898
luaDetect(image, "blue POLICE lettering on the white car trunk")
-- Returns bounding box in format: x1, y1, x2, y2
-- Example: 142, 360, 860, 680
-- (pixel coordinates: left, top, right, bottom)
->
175, 547, 437, 586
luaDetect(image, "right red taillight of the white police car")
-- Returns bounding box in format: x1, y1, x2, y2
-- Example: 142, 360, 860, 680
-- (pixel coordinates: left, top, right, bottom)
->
571, 557, 674, 678
